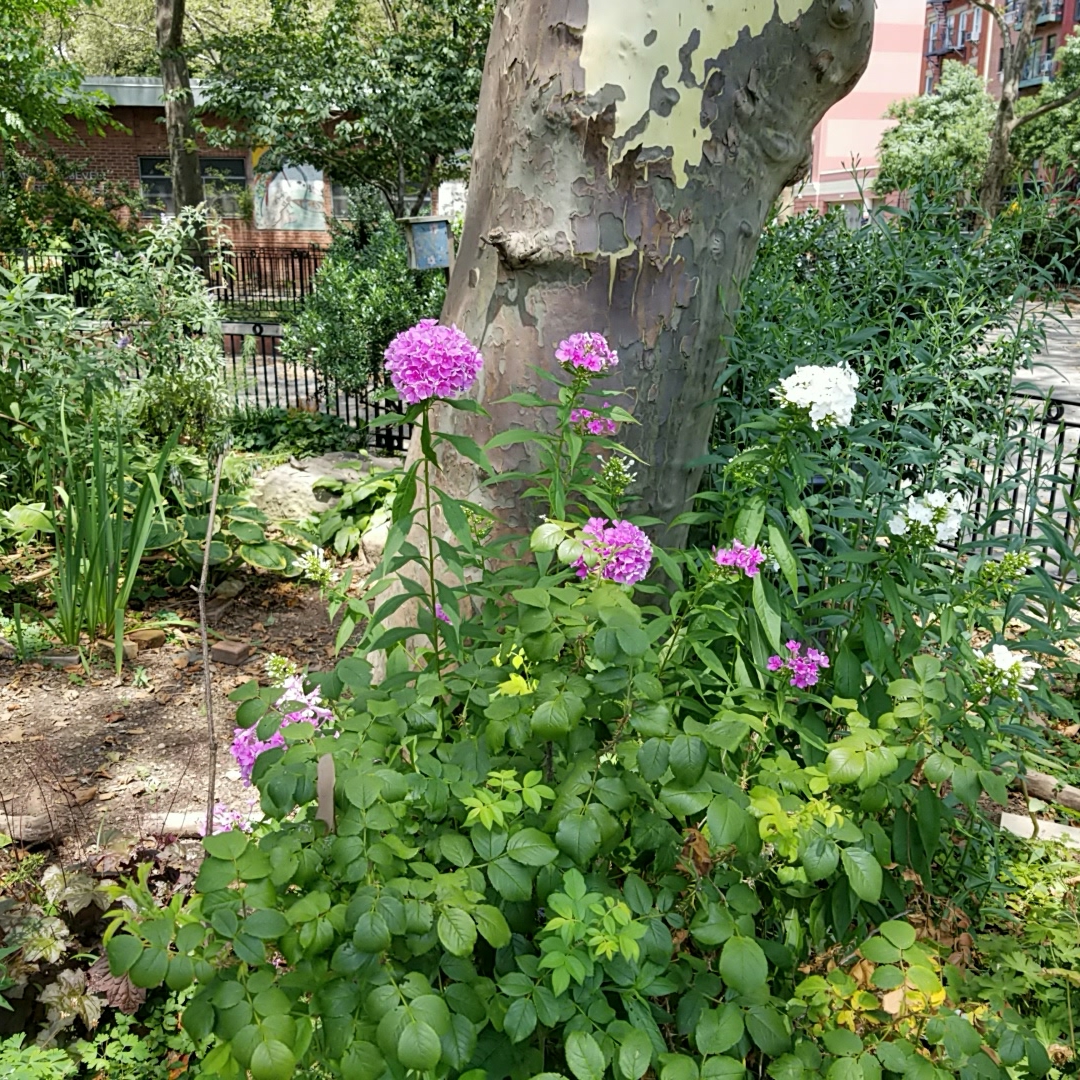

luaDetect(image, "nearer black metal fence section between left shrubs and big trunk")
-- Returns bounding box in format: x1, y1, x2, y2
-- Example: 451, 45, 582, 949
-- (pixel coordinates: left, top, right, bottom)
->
224, 323, 410, 455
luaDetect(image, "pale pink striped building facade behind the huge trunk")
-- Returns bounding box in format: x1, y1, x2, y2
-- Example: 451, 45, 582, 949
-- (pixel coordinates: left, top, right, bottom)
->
792, 0, 927, 221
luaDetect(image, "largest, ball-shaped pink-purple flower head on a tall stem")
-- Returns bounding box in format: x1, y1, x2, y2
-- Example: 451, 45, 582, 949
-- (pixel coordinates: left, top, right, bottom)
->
384, 319, 484, 405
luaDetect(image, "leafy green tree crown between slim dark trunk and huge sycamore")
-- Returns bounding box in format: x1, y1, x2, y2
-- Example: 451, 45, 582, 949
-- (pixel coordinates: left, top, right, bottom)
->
200, 0, 491, 216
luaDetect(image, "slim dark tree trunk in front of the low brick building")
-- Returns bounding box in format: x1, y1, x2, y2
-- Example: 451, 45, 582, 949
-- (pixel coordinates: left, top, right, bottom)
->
156, 0, 204, 213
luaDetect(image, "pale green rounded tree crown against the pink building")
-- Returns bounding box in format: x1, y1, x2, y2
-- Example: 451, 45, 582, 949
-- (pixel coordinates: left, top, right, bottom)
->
874, 60, 996, 194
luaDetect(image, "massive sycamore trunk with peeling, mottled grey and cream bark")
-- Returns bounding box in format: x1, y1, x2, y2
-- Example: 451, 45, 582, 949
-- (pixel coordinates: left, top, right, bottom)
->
427, 0, 874, 543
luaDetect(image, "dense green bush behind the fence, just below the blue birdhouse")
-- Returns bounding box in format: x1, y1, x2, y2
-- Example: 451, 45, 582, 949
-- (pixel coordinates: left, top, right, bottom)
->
282, 195, 446, 393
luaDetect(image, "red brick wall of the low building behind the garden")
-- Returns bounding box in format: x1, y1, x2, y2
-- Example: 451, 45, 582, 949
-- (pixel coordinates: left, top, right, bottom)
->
49, 106, 332, 248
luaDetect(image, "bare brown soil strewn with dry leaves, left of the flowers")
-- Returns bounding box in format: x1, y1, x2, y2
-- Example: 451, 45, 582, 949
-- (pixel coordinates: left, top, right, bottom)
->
0, 576, 341, 859
